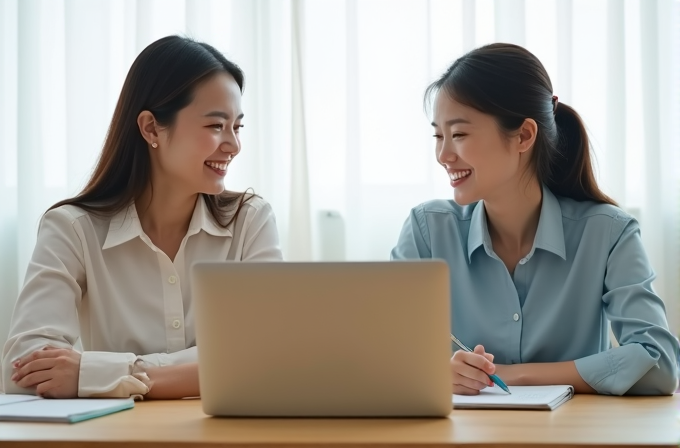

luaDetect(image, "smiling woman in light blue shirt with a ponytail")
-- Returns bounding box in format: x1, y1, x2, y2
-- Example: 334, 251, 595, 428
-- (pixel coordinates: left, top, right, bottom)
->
392, 44, 678, 395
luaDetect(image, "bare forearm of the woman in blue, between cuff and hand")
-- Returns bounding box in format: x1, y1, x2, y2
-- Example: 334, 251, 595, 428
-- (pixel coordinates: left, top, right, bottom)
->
496, 361, 596, 394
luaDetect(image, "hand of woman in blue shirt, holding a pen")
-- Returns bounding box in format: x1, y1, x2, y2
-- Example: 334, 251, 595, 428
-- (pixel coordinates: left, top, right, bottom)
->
451, 345, 496, 395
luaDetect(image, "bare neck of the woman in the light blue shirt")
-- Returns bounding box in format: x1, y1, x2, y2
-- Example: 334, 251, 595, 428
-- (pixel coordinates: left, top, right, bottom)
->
484, 178, 543, 256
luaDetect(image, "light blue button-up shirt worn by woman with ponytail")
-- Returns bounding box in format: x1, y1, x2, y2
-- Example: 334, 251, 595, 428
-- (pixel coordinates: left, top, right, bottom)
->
392, 187, 679, 395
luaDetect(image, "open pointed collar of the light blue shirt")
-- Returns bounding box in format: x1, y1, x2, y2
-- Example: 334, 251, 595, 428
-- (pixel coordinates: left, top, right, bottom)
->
468, 185, 567, 263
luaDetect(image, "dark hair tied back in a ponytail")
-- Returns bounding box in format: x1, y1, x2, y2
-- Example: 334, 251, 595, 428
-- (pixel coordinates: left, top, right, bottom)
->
425, 43, 616, 205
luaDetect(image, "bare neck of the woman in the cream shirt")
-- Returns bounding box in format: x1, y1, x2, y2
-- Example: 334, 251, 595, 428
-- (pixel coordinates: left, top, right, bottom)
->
136, 177, 199, 237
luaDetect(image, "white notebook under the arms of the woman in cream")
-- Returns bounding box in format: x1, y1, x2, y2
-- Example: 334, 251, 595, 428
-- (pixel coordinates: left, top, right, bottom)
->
0, 394, 135, 423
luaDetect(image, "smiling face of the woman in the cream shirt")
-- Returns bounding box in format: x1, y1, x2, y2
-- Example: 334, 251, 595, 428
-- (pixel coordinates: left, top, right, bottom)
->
151, 72, 243, 194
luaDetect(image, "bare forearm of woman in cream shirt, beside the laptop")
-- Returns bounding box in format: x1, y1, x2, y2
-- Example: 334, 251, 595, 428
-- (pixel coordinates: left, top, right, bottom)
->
145, 363, 200, 400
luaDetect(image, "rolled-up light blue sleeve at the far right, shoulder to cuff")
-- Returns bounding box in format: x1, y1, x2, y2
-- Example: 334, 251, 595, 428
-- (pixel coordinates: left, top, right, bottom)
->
576, 218, 679, 395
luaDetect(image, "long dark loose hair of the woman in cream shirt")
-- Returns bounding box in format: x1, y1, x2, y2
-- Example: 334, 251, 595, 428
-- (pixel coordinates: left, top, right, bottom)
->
50, 36, 253, 227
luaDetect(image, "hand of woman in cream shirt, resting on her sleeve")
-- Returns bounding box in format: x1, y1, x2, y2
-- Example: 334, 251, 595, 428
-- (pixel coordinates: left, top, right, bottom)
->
11, 346, 80, 398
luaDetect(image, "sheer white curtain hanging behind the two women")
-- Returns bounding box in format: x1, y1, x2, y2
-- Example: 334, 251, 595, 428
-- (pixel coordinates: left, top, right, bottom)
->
0, 0, 680, 343
